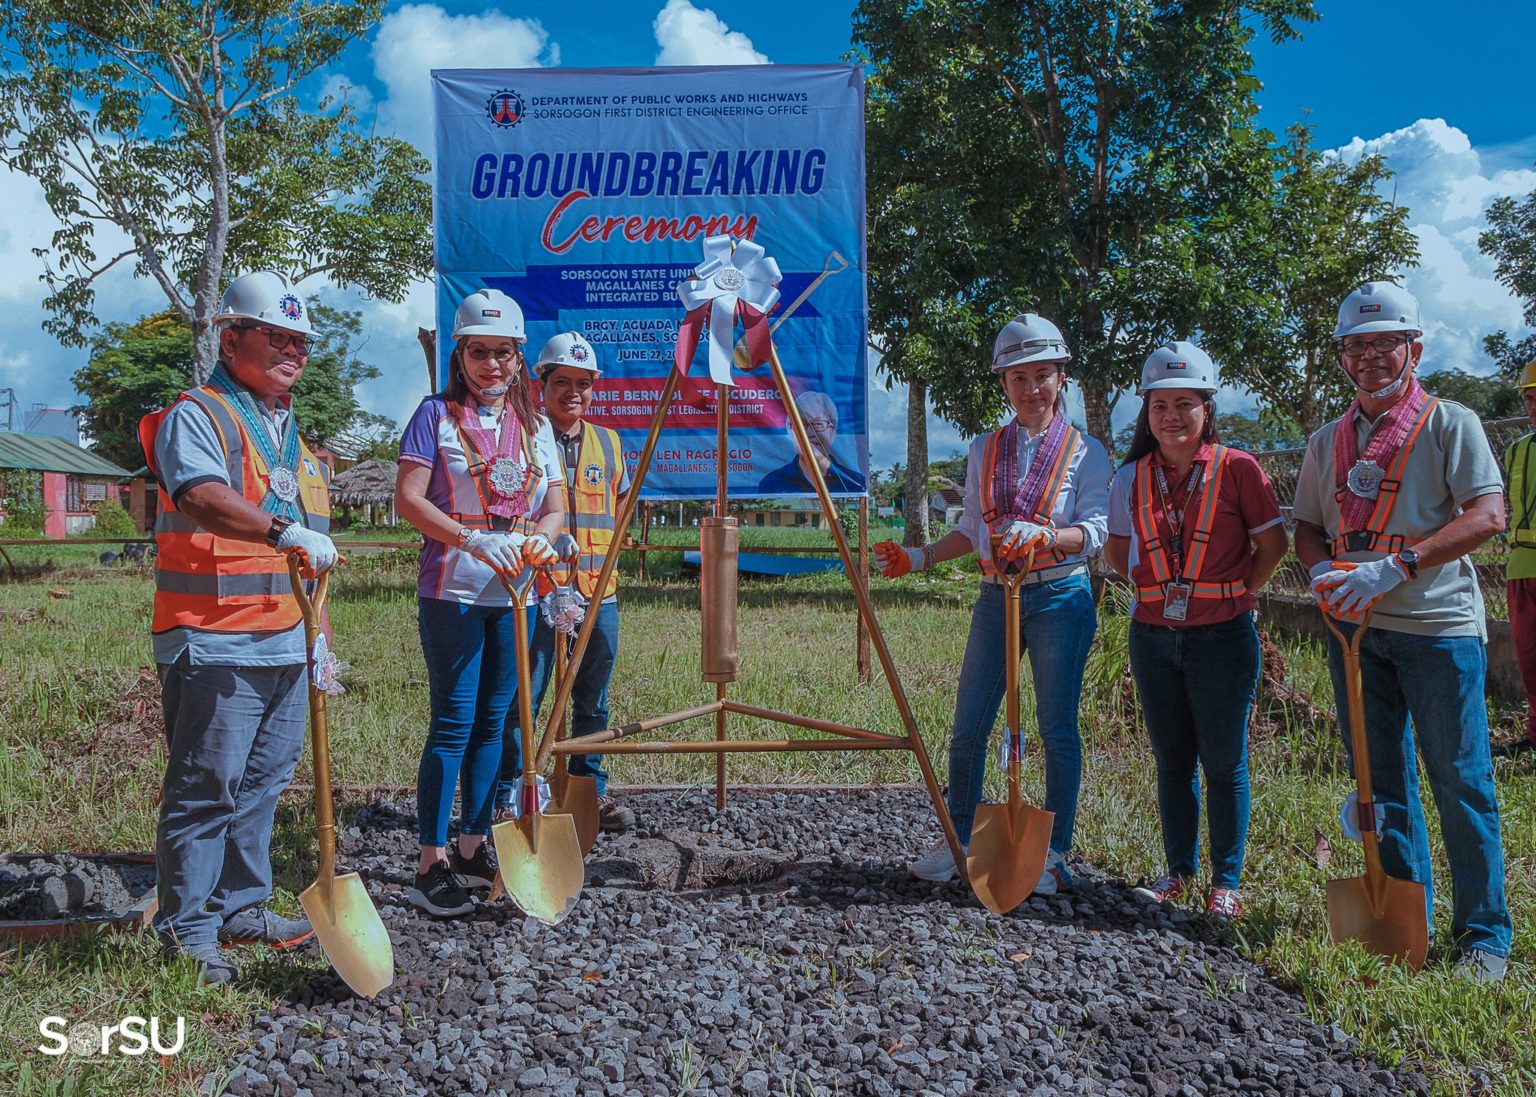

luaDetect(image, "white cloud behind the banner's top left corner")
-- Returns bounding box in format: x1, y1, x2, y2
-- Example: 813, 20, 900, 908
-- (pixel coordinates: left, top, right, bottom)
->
370, 5, 561, 157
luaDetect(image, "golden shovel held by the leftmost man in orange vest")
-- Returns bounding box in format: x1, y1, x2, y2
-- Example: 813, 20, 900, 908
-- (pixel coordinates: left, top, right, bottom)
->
289, 552, 395, 999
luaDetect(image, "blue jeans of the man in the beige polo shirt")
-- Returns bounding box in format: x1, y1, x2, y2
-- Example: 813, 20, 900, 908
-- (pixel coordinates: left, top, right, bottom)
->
1329, 624, 1513, 956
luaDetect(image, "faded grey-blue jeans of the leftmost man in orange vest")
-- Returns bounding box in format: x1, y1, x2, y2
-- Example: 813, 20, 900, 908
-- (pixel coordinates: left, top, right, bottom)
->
155, 651, 309, 946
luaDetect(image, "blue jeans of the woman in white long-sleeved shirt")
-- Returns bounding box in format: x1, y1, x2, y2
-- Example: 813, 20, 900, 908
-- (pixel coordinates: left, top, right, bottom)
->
949, 573, 1098, 853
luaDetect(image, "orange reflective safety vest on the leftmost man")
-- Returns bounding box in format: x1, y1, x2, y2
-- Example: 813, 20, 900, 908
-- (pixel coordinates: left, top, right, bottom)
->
138, 386, 330, 633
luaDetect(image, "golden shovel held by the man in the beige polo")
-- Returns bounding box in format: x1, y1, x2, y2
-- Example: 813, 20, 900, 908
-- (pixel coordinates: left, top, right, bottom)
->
1322, 610, 1430, 971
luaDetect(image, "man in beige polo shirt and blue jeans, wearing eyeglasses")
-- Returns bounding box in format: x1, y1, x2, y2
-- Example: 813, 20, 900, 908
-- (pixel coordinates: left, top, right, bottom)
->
1295, 281, 1511, 982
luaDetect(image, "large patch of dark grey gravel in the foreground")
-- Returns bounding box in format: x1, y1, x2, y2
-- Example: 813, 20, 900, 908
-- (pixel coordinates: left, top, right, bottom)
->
210, 790, 1428, 1097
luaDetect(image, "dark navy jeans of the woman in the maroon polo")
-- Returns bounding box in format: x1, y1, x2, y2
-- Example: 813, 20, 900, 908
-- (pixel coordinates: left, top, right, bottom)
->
1130, 613, 1260, 888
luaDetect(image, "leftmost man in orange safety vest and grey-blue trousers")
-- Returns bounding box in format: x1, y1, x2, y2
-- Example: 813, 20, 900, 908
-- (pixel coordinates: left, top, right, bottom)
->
138, 270, 336, 983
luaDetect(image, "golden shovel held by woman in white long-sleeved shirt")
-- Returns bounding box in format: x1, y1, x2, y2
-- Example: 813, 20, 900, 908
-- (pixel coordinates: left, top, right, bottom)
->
965, 536, 1055, 914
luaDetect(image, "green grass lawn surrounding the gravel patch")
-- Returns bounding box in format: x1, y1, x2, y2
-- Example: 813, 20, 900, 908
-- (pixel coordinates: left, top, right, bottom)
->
0, 550, 1536, 1097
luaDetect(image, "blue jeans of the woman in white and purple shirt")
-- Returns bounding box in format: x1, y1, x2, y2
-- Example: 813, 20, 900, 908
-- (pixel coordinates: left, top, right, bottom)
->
416, 598, 538, 845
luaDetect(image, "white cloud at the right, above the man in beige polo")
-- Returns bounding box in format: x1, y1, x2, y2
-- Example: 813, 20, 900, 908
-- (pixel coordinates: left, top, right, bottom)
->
1338, 118, 1536, 373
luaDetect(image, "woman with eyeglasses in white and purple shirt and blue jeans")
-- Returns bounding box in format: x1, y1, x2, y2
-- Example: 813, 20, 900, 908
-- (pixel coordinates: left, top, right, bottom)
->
395, 289, 565, 917
